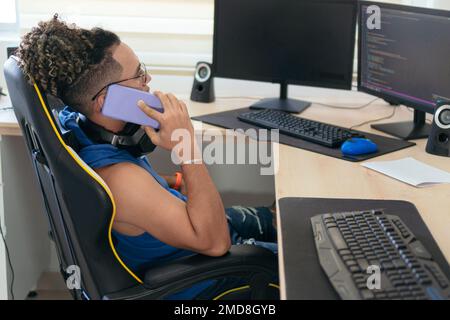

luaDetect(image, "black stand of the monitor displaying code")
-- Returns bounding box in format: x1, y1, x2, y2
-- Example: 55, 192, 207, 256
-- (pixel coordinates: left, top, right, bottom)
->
371, 110, 431, 140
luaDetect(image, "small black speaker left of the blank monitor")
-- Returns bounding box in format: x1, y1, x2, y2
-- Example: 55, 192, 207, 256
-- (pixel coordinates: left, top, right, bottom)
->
191, 62, 215, 102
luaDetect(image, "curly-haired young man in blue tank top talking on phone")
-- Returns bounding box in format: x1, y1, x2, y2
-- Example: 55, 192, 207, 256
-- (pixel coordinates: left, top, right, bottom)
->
18, 15, 276, 298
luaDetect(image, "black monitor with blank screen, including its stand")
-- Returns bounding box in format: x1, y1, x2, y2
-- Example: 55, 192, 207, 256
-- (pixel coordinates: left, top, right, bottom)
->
213, 0, 357, 112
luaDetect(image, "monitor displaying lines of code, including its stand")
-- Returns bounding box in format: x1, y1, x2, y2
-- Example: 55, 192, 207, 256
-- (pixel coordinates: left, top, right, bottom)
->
358, 1, 450, 140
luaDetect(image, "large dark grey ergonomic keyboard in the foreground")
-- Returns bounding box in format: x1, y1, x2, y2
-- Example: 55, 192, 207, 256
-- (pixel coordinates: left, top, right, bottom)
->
311, 210, 450, 300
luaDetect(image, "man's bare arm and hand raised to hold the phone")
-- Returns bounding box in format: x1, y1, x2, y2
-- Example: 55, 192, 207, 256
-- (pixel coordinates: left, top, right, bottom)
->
97, 92, 231, 256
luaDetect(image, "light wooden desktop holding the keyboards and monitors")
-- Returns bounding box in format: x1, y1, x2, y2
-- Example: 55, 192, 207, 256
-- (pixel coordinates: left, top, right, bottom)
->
0, 91, 450, 298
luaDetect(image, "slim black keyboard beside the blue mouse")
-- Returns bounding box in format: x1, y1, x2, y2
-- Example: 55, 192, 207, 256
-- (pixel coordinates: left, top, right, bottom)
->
238, 109, 364, 148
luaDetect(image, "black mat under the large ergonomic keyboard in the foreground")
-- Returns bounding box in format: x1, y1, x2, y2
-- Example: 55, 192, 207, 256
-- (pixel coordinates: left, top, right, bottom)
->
278, 198, 450, 300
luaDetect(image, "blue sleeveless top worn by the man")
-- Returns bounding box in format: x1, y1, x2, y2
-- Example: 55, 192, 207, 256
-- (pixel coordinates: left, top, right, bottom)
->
59, 107, 215, 299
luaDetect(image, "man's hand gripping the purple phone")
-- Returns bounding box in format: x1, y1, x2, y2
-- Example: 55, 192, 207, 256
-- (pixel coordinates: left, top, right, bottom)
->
138, 91, 194, 151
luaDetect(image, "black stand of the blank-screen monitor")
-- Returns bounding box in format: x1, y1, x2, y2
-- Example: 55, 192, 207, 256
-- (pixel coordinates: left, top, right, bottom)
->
250, 82, 311, 113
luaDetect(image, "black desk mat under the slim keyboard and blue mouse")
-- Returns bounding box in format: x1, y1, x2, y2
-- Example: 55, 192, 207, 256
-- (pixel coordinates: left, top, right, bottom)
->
192, 108, 415, 162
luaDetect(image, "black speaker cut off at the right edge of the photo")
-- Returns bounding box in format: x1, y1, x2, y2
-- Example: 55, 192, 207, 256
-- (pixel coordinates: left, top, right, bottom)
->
426, 101, 450, 157
